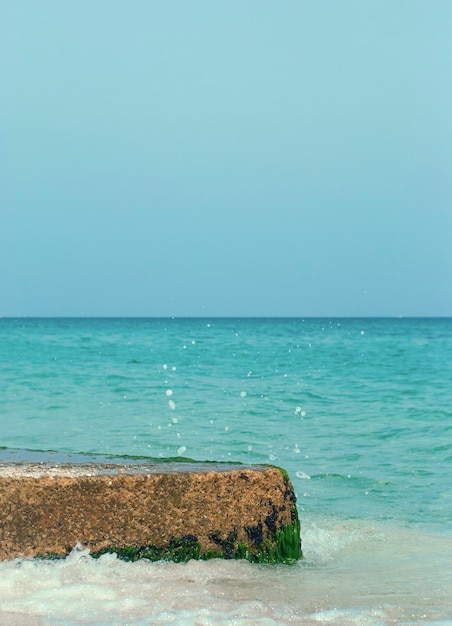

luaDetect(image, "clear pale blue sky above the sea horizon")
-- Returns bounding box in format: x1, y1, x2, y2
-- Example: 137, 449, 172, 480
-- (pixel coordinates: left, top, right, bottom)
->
0, 0, 452, 317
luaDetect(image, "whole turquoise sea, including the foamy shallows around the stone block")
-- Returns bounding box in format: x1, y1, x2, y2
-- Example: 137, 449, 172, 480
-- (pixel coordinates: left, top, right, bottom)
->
0, 318, 452, 626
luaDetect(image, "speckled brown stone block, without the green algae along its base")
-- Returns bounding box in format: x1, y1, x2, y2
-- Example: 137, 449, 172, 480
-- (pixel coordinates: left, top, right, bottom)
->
0, 463, 298, 560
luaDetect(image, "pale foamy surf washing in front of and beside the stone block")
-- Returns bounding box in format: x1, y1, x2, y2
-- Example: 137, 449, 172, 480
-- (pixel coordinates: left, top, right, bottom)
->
0, 520, 452, 626
